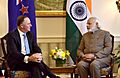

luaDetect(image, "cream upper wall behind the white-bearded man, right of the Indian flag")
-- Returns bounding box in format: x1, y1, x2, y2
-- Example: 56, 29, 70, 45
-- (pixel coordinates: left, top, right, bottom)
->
92, 0, 120, 36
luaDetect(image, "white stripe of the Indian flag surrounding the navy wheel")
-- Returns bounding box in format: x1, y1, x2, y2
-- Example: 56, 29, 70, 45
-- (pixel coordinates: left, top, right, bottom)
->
66, 0, 90, 34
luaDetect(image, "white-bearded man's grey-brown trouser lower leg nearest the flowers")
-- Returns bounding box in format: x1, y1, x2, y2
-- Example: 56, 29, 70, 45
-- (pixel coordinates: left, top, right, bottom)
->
77, 61, 89, 78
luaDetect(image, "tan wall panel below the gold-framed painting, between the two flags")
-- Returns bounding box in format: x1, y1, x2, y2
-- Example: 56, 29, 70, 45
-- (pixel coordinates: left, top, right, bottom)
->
37, 17, 66, 37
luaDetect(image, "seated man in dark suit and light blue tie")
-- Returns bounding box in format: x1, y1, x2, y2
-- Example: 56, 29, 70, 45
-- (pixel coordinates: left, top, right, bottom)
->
7, 16, 60, 78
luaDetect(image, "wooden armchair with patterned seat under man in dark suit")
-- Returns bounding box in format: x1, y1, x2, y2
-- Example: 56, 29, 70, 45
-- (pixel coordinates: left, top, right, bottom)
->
1, 33, 30, 78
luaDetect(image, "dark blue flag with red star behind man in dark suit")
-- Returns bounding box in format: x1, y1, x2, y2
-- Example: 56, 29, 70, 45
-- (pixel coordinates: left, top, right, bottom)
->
8, 0, 36, 40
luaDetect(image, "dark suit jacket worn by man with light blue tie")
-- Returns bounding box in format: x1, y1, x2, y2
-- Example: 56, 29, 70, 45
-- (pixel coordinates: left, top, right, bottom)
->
7, 29, 41, 69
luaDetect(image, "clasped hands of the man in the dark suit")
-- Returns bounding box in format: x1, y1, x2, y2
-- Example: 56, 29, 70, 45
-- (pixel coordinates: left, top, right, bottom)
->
28, 53, 42, 63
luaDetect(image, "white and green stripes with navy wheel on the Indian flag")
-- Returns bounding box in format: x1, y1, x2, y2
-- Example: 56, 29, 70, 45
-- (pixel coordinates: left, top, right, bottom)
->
66, 0, 91, 63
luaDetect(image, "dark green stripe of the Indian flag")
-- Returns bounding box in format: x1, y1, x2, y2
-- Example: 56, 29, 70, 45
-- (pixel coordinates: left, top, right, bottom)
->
66, 13, 82, 63
